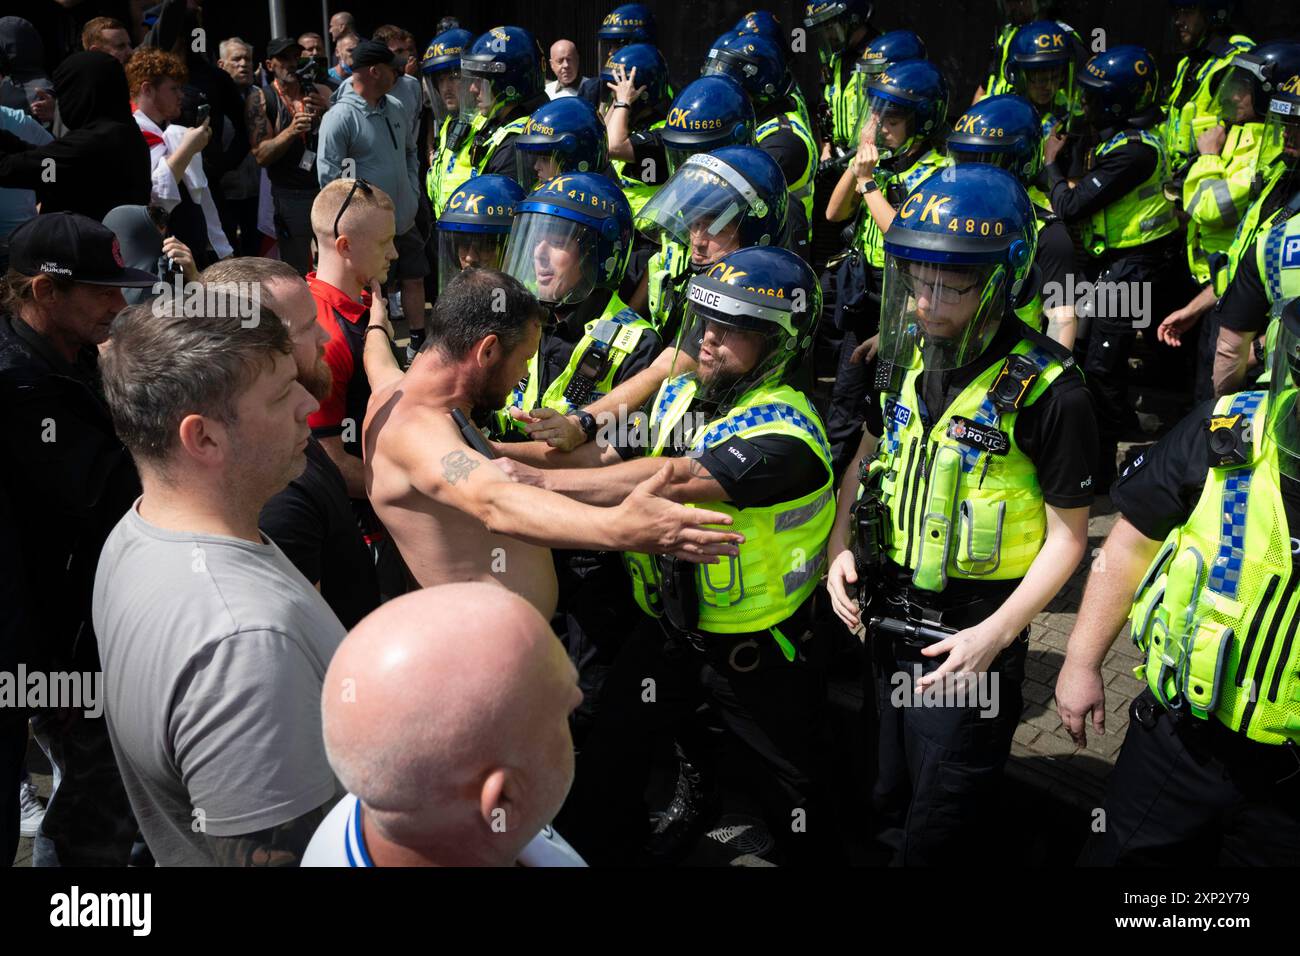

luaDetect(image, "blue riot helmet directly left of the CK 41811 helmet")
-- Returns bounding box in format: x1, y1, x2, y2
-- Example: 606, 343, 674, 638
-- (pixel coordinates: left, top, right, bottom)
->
437, 173, 525, 294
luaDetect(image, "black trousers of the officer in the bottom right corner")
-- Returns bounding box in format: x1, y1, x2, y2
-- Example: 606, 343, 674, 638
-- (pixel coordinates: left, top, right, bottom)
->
1080, 689, 1300, 866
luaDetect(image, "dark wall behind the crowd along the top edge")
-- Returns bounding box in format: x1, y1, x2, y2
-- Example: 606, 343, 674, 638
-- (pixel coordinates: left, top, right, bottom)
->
204, 0, 1300, 112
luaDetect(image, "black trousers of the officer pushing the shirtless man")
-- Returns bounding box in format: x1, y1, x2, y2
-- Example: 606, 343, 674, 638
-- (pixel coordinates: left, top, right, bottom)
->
556, 606, 840, 865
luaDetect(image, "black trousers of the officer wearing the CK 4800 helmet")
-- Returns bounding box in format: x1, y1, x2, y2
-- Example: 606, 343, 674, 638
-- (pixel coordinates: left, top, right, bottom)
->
870, 630, 1028, 866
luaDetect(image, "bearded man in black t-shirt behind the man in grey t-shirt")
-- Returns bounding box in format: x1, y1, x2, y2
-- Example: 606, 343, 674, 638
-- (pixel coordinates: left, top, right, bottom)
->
202, 258, 382, 627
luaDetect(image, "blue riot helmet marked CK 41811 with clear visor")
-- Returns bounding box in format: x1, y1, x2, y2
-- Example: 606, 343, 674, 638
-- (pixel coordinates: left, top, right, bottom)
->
501, 173, 632, 307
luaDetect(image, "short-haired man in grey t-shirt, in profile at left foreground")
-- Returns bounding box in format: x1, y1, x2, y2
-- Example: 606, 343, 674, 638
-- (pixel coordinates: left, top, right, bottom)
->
94, 280, 345, 866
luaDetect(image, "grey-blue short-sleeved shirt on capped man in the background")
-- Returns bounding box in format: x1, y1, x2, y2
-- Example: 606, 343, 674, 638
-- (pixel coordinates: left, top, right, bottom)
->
316, 83, 420, 235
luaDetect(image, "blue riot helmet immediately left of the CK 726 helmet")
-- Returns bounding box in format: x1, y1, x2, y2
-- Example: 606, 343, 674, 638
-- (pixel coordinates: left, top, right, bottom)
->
855, 60, 948, 163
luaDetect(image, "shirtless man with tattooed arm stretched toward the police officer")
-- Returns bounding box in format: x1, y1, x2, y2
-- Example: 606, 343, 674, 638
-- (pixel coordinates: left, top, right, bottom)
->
364, 269, 744, 619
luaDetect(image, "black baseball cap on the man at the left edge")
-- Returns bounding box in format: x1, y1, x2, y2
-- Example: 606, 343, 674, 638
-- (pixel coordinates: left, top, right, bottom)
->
9, 212, 159, 289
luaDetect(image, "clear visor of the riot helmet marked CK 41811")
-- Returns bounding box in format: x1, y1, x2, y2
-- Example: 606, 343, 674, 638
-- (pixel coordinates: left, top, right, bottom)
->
502, 212, 597, 306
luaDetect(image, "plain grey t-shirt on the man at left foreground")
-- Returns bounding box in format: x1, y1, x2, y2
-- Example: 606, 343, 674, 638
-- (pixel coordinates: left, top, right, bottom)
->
94, 501, 345, 866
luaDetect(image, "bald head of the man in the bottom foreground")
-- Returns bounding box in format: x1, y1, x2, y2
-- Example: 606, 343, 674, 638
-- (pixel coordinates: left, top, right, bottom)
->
322, 583, 581, 865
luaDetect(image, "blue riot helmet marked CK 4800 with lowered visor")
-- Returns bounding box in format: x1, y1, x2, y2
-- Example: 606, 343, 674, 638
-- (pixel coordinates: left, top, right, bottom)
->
879, 164, 1037, 369
